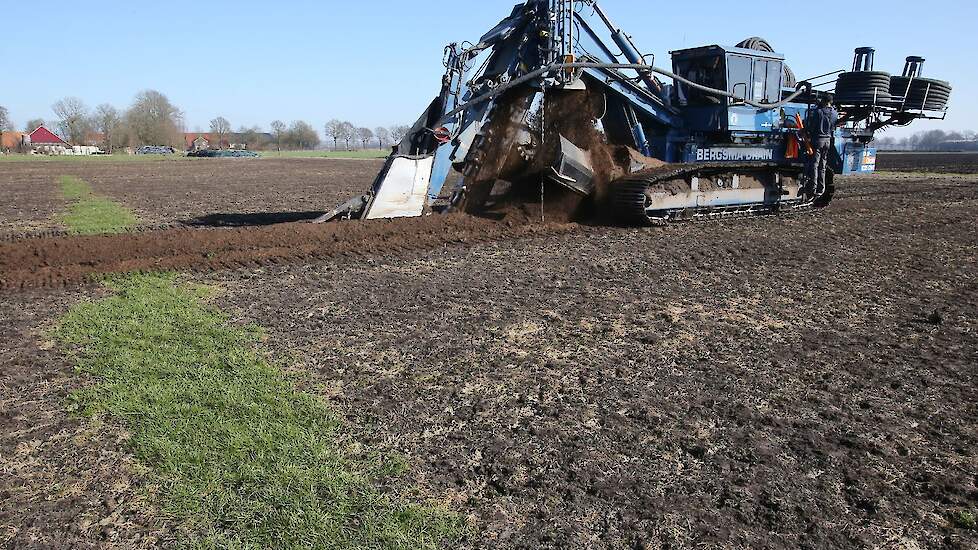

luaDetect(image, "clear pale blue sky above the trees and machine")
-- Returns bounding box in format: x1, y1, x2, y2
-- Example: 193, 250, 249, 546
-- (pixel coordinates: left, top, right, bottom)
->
0, 0, 978, 136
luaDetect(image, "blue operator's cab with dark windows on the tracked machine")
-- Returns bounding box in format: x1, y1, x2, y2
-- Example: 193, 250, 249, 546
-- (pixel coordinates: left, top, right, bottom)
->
672, 45, 784, 132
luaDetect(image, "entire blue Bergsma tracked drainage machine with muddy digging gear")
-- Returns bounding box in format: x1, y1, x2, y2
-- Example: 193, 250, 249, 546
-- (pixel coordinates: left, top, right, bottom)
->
320, 0, 950, 225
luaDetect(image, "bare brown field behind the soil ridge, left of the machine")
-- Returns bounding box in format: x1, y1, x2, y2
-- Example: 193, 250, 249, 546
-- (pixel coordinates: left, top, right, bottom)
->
0, 159, 383, 235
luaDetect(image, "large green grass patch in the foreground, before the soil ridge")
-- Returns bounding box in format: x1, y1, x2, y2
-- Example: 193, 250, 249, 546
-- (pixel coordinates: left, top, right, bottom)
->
56, 275, 464, 549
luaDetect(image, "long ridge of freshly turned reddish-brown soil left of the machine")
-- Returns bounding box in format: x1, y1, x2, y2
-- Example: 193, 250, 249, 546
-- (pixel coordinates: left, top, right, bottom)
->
0, 214, 581, 290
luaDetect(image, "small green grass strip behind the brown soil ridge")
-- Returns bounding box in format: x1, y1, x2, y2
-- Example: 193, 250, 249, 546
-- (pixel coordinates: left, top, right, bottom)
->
58, 176, 139, 235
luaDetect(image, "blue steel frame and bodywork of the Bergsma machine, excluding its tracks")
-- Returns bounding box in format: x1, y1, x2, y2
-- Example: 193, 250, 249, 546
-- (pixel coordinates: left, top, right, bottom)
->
324, 0, 944, 224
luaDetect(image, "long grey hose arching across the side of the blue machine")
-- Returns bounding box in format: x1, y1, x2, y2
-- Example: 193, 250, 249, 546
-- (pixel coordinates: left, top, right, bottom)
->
437, 61, 811, 126
